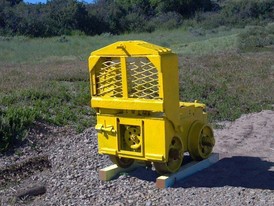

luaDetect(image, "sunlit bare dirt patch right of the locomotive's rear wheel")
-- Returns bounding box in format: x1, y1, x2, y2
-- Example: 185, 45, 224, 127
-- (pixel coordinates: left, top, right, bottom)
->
214, 110, 274, 162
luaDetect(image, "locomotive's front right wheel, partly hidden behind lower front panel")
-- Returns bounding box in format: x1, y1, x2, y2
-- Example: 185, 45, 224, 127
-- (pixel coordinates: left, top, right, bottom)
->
153, 137, 184, 174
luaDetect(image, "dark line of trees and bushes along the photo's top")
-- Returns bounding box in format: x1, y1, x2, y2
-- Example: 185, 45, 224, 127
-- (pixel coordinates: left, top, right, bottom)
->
0, 0, 274, 37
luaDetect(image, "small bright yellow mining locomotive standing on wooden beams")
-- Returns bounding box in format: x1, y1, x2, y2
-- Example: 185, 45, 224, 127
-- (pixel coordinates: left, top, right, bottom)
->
89, 41, 215, 174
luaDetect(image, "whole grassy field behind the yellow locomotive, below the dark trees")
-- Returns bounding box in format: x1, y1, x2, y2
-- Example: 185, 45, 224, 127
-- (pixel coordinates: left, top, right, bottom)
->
0, 28, 274, 151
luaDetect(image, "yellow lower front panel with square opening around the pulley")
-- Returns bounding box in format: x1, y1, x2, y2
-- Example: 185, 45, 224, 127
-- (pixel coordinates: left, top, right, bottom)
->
96, 115, 170, 161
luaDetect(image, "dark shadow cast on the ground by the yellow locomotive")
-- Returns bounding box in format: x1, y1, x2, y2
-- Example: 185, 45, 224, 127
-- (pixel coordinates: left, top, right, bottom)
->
130, 156, 274, 190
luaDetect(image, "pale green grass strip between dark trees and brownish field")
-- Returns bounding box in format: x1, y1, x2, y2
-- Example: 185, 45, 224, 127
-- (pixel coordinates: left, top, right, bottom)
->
0, 28, 243, 65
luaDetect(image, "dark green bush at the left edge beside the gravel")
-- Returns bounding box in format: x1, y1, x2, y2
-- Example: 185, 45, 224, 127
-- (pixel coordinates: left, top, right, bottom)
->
0, 107, 38, 152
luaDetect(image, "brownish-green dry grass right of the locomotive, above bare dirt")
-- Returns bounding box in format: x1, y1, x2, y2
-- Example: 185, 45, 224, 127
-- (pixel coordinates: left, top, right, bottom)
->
180, 51, 274, 120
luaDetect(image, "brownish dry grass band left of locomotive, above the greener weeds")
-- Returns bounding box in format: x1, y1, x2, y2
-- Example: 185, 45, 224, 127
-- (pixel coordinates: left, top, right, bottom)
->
0, 60, 89, 93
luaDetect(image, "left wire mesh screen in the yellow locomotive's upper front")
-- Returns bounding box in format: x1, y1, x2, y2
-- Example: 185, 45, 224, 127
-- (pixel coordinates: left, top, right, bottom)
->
96, 60, 123, 97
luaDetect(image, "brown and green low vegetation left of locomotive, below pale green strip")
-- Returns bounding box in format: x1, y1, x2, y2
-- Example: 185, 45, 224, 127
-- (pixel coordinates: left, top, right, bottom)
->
0, 60, 95, 136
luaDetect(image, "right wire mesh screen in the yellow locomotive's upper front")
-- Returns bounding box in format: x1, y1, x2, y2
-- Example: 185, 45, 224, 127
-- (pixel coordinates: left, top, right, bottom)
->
127, 58, 159, 99
